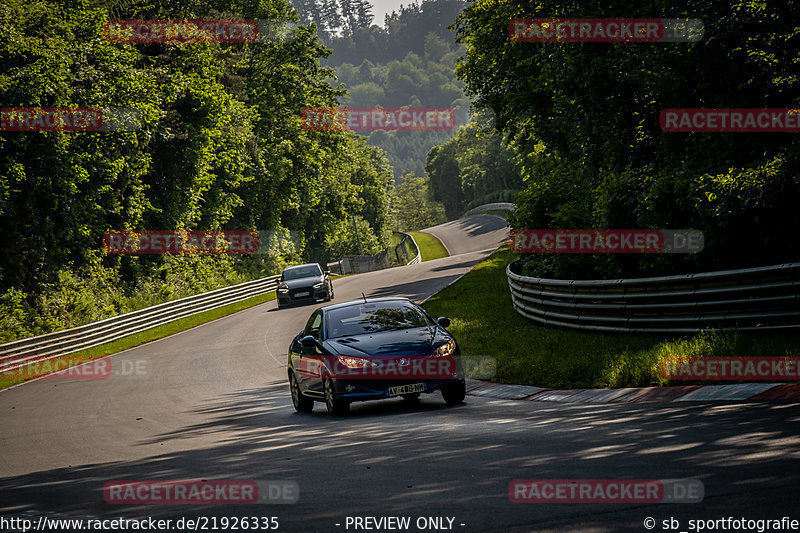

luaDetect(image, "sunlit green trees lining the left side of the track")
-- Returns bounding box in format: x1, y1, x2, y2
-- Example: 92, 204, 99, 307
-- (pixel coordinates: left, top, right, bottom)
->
0, 0, 392, 338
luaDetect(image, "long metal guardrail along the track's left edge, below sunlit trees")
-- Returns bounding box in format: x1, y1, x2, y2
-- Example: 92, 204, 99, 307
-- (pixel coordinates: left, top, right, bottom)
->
0, 276, 280, 373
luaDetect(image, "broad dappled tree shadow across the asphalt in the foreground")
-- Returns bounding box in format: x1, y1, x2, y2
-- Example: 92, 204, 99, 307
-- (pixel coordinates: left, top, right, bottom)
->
0, 383, 800, 531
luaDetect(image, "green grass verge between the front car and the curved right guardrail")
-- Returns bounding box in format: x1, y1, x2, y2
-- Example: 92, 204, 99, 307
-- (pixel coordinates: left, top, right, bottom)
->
423, 245, 800, 388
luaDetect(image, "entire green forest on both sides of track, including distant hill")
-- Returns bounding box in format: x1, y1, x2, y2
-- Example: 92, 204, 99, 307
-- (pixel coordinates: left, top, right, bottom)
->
0, 0, 800, 341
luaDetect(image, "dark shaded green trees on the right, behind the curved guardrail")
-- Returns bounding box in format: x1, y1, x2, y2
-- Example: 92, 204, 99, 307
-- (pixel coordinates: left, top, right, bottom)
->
455, 0, 800, 278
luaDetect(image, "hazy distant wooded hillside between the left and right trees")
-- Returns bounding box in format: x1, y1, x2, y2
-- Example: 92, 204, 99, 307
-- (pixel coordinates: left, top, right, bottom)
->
295, 0, 469, 180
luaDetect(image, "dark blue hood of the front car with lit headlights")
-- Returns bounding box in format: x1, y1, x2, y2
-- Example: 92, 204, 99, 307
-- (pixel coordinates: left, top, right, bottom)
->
325, 326, 452, 357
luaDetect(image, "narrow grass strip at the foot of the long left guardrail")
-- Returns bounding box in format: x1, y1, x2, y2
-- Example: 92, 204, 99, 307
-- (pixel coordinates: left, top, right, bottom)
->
0, 291, 275, 390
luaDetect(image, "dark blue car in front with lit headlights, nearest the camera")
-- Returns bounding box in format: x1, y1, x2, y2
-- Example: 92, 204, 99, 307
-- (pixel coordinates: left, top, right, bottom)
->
288, 298, 466, 416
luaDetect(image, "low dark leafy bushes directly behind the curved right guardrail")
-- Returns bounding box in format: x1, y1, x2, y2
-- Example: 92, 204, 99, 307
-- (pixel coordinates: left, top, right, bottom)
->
509, 154, 800, 279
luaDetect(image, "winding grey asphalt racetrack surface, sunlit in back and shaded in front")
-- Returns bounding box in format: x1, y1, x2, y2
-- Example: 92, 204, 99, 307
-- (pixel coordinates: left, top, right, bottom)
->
0, 216, 800, 532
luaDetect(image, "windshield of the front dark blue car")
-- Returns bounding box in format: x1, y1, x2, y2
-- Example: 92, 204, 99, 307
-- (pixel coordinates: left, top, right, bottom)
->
327, 302, 433, 338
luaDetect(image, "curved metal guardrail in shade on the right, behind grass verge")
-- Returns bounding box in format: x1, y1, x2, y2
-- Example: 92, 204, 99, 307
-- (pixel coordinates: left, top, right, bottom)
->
506, 263, 800, 334
